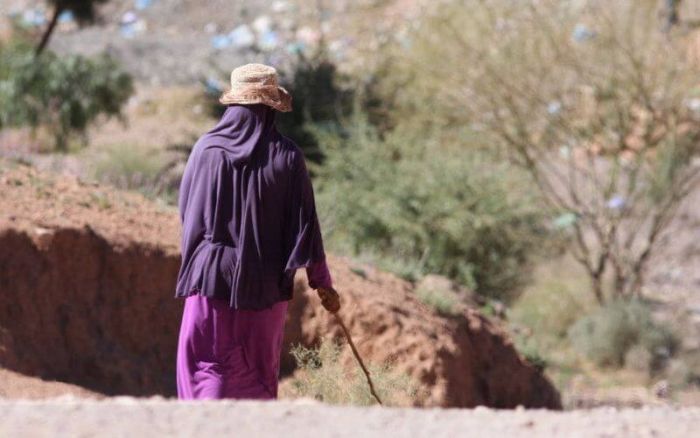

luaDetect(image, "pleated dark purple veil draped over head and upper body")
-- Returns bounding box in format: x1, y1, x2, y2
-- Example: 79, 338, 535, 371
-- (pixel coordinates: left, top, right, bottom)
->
175, 105, 325, 310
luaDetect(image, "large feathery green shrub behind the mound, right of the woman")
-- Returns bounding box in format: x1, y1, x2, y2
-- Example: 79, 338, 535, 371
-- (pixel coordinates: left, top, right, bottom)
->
316, 117, 542, 301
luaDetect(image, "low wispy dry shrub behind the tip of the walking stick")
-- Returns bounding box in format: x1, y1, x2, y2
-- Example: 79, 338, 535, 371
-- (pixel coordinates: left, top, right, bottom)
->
291, 340, 416, 406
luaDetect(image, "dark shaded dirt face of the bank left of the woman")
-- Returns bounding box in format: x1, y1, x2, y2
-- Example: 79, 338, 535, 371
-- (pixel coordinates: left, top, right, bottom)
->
0, 229, 181, 395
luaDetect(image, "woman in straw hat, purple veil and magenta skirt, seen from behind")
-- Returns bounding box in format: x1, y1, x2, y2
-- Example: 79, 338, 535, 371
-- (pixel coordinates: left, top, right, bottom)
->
176, 64, 340, 399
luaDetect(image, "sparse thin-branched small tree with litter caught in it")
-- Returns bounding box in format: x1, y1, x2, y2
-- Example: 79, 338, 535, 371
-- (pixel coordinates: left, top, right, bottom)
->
397, 1, 700, 303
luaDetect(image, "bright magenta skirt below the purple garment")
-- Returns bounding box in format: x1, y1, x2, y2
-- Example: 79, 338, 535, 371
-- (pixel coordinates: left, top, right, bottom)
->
177, 295, 288, 400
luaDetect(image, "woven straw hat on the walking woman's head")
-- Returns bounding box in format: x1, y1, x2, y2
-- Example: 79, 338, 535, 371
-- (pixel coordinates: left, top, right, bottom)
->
219, 64, 292, 112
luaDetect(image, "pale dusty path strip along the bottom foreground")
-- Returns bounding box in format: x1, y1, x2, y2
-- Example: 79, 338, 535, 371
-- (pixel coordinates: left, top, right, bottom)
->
0, 398, 700, 438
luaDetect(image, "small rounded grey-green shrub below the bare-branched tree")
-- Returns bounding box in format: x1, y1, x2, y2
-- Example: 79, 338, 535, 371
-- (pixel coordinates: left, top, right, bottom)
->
569, 299, 677, 371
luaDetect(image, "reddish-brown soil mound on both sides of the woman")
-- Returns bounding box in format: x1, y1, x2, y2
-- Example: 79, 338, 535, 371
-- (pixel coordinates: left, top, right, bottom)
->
0, 162, 560, 408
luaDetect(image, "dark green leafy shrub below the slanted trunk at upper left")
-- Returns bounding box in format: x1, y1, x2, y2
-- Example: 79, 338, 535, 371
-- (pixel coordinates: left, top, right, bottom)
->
0, 42, 133, 151
